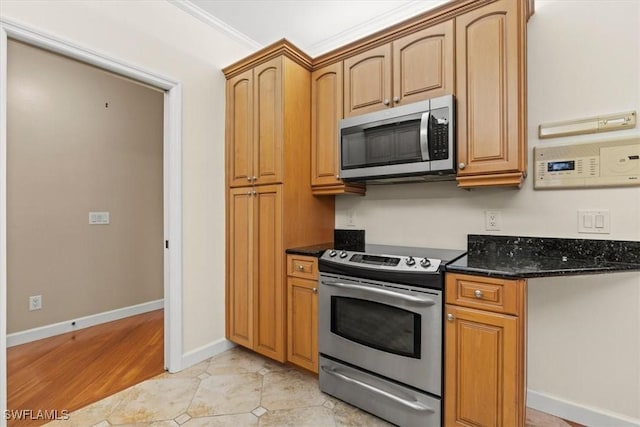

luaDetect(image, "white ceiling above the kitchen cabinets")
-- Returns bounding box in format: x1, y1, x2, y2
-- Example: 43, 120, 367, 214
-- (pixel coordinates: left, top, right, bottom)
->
170, 0, 448, 57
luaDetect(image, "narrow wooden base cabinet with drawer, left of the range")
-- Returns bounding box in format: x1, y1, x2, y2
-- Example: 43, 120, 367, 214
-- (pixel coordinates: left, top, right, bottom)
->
287, 255, 318, 373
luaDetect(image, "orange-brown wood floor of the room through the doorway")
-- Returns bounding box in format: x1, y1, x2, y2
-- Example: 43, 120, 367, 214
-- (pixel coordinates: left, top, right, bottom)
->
7, 310, 164, 427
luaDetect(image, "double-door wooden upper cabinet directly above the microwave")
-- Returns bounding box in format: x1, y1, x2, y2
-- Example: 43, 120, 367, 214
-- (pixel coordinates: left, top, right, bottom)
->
344, 20, 454, 117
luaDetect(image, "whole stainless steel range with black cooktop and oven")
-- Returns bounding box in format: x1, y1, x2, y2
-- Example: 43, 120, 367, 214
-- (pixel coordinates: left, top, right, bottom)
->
318, 245, 464, 426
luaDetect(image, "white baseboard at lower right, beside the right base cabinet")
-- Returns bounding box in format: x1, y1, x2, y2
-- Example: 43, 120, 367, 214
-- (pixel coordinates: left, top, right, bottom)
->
527, 389, 640, 427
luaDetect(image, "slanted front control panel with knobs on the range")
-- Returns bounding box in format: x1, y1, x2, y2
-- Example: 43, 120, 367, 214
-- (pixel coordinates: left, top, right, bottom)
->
320, 249, 441, 273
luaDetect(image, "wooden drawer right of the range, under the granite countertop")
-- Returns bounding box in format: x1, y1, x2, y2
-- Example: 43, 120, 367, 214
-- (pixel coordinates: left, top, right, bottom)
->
445, 274, 526, 315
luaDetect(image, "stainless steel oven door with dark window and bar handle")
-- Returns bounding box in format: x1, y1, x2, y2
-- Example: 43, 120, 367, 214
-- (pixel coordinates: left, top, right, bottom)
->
318, 273, 442, 396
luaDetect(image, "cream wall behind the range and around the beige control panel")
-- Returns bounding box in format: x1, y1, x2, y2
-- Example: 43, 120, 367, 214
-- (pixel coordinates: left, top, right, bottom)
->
336, 0, 640, 425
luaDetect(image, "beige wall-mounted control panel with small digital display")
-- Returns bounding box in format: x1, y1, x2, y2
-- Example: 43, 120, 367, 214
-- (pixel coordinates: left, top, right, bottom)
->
533, 136, 640, 190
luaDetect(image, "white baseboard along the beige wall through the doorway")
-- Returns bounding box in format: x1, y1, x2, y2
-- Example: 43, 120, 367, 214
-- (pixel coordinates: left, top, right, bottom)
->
7, 299, 164, 347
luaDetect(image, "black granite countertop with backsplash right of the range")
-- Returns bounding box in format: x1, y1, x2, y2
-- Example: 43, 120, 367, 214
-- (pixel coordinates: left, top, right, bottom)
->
446, 235, 640, 278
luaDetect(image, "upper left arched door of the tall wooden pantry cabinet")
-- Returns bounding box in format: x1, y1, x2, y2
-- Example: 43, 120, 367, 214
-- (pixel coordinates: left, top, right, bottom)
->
226, 70, 253, 187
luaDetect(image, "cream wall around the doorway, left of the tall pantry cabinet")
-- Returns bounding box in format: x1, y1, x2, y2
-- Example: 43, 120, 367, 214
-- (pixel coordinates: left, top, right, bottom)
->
0, 0, 255, 353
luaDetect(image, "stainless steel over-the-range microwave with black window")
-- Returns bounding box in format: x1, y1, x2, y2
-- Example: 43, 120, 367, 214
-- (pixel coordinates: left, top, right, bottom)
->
339, 95, 455, 182
